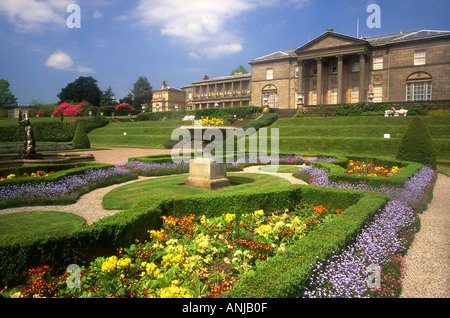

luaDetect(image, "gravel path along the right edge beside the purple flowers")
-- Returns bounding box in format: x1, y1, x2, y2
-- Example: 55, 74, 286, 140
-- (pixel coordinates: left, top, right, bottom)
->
401, 174, 450, 298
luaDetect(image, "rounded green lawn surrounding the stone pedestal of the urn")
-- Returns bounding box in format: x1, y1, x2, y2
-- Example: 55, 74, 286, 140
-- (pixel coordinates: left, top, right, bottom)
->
103, 173, 290, 210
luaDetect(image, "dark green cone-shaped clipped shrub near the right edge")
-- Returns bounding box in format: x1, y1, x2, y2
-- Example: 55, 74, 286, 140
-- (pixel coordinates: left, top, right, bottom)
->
395, 115, 436, 169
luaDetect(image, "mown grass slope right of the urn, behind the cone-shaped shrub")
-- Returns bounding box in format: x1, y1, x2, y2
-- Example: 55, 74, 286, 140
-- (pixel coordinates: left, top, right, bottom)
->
270, 116, 450, 161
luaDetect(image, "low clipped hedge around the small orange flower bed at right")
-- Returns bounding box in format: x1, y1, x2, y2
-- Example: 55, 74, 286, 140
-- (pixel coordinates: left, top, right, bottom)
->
313, 156, 422, 187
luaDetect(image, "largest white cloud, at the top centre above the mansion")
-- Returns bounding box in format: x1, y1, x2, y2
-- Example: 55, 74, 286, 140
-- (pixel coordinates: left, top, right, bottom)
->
136, 0, 309, 58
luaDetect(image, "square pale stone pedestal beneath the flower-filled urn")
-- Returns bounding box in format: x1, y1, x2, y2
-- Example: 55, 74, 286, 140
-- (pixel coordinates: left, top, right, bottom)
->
185, 158, 231, 189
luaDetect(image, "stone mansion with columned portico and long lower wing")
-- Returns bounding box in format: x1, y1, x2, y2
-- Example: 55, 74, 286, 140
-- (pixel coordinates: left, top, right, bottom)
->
152, 29, 450, 111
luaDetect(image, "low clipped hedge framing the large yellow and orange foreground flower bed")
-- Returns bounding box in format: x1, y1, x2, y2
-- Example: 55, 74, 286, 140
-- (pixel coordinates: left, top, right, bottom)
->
0, 181, 388, 290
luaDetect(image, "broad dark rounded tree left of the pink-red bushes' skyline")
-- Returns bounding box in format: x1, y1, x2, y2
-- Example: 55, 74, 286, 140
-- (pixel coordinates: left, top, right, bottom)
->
57, 76, 102, 106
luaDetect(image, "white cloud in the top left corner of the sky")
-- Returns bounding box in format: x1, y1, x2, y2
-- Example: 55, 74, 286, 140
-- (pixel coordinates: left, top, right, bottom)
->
0, 0, 75, 32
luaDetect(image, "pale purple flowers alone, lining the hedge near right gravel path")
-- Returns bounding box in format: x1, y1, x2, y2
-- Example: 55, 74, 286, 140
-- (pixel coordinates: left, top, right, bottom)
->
301, 166, 436, 298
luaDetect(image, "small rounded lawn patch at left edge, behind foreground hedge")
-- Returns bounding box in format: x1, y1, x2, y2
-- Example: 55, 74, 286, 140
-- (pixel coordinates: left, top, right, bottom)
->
0, 211, 86, 238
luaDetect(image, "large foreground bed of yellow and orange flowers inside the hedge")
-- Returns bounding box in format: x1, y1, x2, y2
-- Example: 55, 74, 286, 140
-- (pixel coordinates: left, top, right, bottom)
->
1, 205, 342, 298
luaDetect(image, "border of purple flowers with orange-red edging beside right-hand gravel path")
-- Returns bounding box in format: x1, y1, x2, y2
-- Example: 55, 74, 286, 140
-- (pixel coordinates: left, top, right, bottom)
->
296, 166, 437, 298
